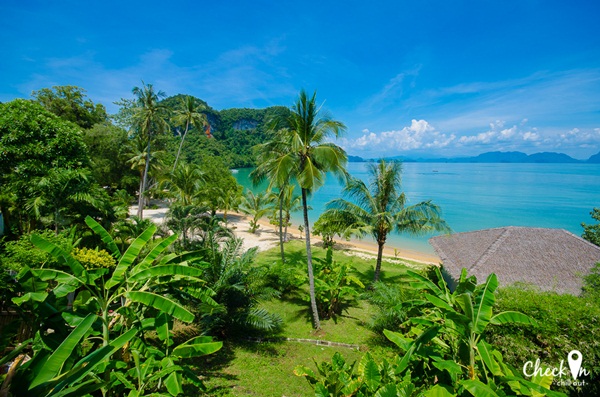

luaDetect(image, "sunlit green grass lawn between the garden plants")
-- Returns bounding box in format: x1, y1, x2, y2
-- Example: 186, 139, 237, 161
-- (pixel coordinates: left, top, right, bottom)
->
200, 240, 423, 397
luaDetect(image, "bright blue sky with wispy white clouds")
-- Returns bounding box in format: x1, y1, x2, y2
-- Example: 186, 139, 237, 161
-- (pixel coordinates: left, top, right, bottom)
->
0, 0, 600, 159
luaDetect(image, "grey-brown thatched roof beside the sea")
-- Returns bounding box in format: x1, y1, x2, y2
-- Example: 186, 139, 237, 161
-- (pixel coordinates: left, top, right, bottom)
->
429, 226, 600, 295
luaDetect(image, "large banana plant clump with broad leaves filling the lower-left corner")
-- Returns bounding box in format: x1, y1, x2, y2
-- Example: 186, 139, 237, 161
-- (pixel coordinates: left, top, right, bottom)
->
2, 218, 221, 396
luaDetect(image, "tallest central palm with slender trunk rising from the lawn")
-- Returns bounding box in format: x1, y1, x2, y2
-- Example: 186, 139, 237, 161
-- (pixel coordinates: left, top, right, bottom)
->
257, 90, 347, 329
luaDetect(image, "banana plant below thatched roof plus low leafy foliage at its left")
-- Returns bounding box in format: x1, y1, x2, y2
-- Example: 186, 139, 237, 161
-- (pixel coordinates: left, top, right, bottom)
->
295, 270, 562, 396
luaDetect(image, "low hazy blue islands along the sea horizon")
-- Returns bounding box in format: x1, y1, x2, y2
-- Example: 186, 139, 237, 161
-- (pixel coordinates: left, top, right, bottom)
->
348, 152, 600, 164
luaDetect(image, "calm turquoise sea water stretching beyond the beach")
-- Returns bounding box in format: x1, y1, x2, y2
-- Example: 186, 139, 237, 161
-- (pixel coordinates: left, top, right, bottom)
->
235, 163, 600, 254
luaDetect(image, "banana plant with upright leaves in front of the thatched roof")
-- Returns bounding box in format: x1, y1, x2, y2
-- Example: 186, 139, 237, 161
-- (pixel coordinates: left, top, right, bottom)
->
384, 268, 560, 396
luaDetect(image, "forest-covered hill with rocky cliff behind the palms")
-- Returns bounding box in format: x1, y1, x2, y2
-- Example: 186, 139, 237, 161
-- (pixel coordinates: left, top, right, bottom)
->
162, 95, 289, 168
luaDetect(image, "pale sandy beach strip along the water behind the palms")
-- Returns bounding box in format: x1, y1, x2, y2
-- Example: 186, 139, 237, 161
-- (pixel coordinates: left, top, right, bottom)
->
129, 204, 440, 265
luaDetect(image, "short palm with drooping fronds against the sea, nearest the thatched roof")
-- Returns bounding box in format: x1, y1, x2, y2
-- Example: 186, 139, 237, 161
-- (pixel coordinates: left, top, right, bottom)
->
321, 160, 450, 282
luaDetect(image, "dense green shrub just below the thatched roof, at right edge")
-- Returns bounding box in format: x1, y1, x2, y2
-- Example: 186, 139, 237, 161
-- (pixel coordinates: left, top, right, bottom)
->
486, 286, 600, 396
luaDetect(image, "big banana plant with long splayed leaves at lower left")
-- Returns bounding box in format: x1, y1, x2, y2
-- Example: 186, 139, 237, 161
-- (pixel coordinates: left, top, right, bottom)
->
13, 217, 222, 396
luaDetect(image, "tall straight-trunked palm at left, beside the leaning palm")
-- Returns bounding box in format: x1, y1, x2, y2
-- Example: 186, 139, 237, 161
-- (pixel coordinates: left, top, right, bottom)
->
132, 81, 169, 218
